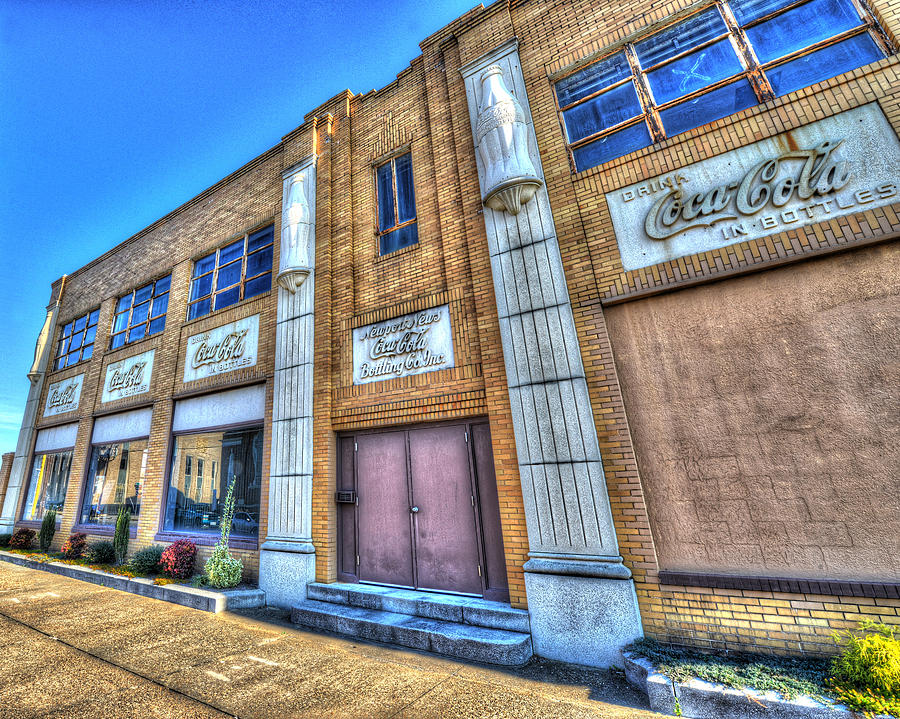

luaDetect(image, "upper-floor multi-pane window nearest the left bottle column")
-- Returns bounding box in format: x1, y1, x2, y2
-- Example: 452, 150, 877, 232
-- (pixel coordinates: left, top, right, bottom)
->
188, 225, 275, 320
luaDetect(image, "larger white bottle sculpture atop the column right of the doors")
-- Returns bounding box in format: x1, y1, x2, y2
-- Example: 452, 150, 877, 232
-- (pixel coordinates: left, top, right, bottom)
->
475, 65, 542, 215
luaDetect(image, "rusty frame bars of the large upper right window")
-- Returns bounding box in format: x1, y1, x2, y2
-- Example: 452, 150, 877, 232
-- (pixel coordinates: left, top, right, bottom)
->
552, 0, 896, 173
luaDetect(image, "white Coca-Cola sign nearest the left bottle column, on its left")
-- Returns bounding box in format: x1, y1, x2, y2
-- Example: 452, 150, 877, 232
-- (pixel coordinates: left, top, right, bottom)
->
184, 315, 259, 382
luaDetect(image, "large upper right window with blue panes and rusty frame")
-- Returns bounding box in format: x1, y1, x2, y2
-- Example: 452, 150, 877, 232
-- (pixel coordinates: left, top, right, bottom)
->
556, 0, 892, 171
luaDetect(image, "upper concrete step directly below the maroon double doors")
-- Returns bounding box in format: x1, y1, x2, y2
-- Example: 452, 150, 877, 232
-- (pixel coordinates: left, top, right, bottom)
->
306, 582, 531, 634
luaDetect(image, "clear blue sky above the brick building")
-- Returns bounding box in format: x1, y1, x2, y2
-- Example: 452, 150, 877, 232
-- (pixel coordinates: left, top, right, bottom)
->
0, 0, 478, 452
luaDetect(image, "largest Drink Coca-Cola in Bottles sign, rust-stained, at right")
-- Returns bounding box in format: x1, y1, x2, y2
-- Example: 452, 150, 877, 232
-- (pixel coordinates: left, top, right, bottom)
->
606, 103, 900, 270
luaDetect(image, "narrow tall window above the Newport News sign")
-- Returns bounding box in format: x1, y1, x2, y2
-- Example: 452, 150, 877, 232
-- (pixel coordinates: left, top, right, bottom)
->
375, 153, 419, 255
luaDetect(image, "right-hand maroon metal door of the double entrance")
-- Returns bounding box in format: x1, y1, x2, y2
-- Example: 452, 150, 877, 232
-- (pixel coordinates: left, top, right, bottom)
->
409, 426, 482, 595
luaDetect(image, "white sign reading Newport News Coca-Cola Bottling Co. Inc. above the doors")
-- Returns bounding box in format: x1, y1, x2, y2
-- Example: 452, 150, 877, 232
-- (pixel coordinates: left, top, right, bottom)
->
353, 305, 454, 384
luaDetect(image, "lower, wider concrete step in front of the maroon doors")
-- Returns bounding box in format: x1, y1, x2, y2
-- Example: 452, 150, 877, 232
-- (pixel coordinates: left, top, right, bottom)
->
291, 599, 531, 666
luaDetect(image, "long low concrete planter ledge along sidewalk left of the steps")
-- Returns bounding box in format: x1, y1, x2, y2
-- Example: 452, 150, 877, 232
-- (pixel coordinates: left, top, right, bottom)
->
0, 550, 266, 614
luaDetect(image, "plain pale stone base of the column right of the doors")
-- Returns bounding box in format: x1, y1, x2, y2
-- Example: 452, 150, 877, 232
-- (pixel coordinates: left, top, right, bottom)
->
525, 571, 644, 667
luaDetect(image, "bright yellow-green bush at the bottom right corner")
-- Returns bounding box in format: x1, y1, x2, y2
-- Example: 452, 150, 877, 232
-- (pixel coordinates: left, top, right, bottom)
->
830, 620, 900, 716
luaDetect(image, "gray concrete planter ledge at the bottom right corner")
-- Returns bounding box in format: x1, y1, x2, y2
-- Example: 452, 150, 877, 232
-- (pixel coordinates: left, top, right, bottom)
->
622, 652, 890, 719
